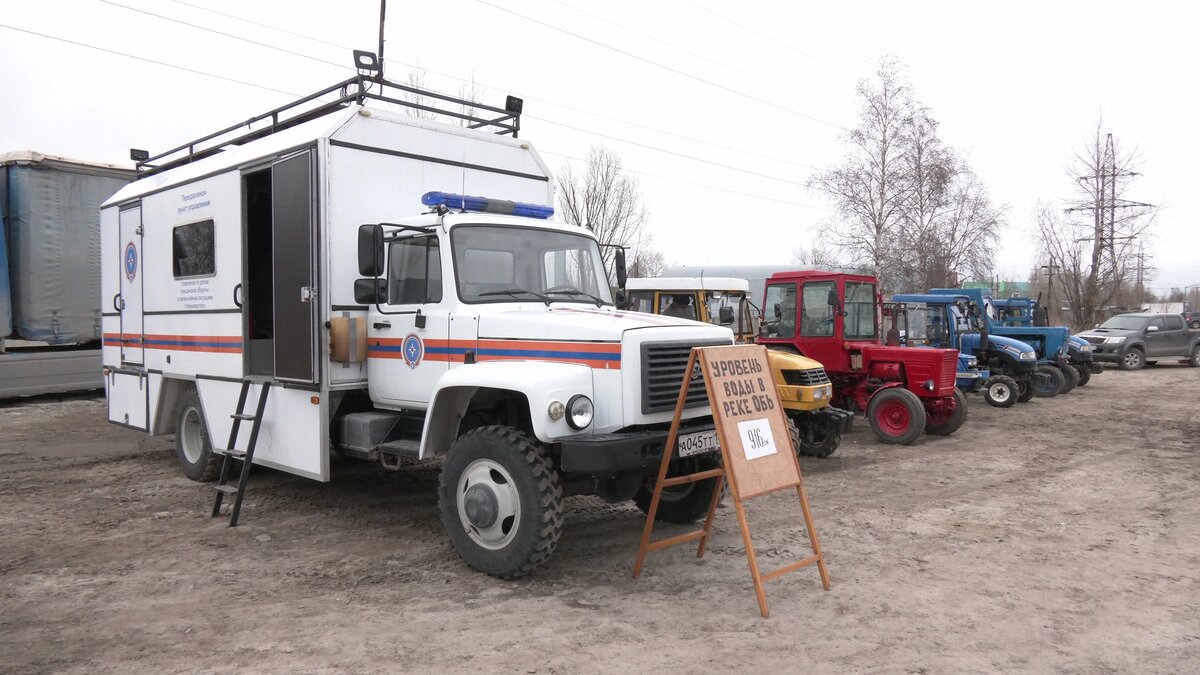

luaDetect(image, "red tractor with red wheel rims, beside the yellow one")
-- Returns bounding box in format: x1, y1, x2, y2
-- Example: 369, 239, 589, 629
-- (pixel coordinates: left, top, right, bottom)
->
757, 270, 967, 443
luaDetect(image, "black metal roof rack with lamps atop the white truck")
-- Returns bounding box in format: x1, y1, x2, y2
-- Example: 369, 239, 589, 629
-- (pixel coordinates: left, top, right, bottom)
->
130, 74, 523, 177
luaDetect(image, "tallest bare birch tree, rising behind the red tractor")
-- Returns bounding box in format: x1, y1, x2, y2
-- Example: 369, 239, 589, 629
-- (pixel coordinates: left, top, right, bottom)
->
809, 58, 916, 285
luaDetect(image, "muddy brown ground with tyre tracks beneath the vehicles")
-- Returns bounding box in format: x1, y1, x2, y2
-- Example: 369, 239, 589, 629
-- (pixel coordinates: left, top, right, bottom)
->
0, 364, 1200, 673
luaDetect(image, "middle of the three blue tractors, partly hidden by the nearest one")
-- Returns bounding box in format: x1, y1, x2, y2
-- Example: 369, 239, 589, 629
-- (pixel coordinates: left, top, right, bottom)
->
930, 288, 1080, 396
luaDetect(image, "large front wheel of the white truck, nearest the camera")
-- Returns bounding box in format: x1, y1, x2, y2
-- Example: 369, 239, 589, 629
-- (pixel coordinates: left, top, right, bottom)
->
438, 426, 563, 579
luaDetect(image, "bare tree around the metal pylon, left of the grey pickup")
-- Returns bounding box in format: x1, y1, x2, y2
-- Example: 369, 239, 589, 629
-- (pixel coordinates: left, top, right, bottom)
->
1038, 124, 1153, 328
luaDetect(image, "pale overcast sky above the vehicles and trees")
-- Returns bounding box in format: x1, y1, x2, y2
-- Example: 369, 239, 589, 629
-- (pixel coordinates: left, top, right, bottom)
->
0, 0, 1200, 292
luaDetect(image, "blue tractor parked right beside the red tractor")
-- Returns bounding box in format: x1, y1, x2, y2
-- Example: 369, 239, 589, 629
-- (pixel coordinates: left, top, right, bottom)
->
883, 293, 1039, 407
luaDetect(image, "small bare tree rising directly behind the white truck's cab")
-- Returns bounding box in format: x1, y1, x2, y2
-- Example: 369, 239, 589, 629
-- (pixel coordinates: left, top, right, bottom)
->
557, 145, 648, 279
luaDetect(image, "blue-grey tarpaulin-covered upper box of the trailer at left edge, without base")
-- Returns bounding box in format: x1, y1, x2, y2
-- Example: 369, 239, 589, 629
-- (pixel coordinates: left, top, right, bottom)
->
0, 153, 134, 345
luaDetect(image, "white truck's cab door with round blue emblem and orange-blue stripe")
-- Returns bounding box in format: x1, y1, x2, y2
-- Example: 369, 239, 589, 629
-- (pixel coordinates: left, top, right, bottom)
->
367, 234, 452, 410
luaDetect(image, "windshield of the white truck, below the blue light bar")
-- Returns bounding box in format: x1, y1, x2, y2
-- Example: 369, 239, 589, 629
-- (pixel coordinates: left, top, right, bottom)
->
450, 225, 612, 305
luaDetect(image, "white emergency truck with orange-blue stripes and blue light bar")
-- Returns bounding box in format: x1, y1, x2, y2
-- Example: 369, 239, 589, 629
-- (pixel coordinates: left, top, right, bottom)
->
101, 76, 733, 578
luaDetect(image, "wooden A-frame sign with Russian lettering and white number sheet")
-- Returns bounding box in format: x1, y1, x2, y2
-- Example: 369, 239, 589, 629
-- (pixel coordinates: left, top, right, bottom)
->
634, 345, 829, 616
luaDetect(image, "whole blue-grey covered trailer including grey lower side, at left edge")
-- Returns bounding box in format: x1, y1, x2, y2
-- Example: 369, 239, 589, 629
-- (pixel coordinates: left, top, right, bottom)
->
0, 151, 136, 398
